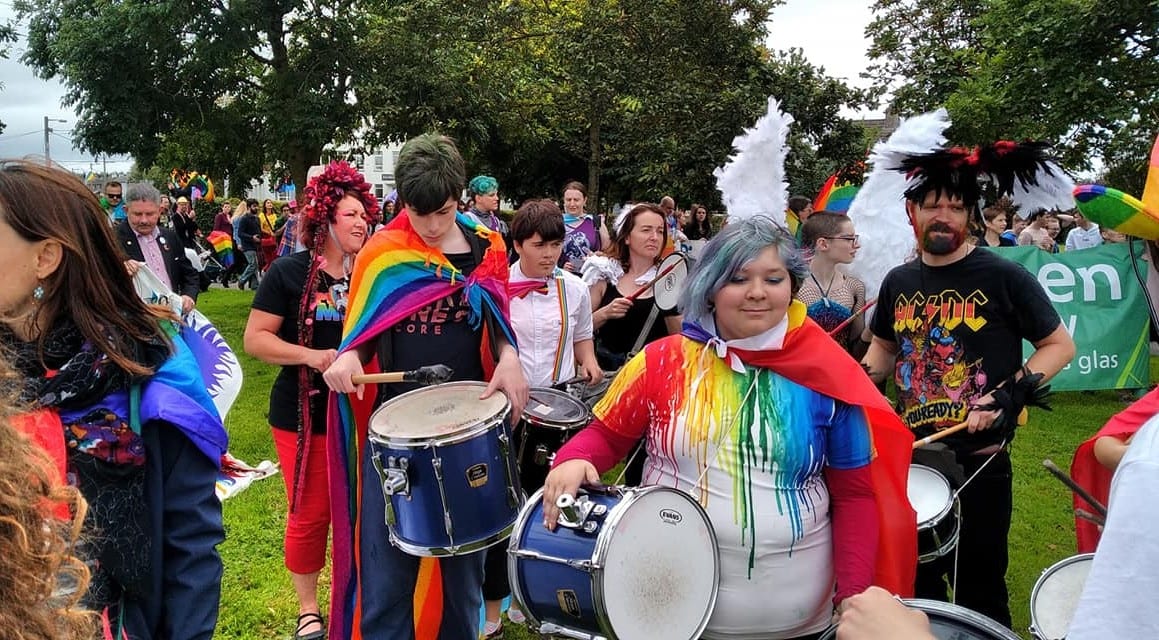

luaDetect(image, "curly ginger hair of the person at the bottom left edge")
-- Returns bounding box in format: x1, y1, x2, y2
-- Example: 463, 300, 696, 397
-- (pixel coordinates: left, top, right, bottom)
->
0, 364, 96, 640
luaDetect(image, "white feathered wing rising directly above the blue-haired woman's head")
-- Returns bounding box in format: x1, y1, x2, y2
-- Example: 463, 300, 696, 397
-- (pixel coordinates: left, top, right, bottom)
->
713, 96, 793, 225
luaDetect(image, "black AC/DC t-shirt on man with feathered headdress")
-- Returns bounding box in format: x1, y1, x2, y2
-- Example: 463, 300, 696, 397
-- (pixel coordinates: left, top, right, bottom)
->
870, 249, 1062, 452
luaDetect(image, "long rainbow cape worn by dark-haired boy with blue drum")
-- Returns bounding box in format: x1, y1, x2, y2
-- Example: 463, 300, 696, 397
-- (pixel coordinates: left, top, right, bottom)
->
326, 213, 516, 640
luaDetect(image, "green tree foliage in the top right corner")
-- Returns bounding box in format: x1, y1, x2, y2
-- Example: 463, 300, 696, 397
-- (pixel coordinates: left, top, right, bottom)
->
866, 0, 1159, 176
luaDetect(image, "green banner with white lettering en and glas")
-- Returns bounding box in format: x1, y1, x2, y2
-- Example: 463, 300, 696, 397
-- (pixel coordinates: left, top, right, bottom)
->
993, 243, 1151, 391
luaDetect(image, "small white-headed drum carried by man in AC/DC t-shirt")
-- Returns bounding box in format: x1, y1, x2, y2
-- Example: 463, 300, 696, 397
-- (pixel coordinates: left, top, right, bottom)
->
905, 465, 961, 562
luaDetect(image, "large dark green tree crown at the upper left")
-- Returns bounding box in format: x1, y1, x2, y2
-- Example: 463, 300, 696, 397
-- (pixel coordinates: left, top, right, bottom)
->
17, 0, 365, 192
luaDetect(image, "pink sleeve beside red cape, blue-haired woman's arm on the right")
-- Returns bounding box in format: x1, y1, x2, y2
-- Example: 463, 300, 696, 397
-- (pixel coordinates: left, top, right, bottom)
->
825, 465, 880, 605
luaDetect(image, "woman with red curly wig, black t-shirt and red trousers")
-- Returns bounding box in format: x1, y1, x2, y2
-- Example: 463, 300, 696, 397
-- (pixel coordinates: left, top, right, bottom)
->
246, 162, 378, 640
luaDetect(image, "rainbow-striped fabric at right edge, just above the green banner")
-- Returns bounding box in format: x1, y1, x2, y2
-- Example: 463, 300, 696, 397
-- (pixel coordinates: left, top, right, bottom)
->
1074, 136, 1159, 240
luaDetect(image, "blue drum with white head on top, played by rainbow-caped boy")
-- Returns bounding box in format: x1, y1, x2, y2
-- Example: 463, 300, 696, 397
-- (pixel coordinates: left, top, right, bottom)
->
370, 383, 523, 557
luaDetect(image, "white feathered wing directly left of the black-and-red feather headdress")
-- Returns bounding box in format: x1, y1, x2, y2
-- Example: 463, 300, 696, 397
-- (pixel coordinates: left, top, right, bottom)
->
850, 109, 950, 300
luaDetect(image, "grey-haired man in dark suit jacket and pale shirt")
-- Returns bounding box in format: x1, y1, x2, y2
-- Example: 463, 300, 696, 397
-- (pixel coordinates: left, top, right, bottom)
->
117, 184, 201, 313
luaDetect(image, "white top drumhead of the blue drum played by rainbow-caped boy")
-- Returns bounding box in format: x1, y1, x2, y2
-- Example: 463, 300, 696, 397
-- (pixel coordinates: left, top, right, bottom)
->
370, 383, 508, 439
